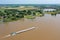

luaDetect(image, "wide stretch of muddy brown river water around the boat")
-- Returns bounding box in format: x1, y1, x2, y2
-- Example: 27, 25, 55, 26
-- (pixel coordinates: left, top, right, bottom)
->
0, 14, 60, 40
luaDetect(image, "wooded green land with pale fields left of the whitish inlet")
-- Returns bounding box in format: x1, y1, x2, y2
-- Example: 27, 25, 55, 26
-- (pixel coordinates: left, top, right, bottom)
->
0, 6, 44, 22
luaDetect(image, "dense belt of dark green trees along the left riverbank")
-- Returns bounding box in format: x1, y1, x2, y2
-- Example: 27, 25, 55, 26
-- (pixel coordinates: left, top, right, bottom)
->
0, 9, 42, 22
